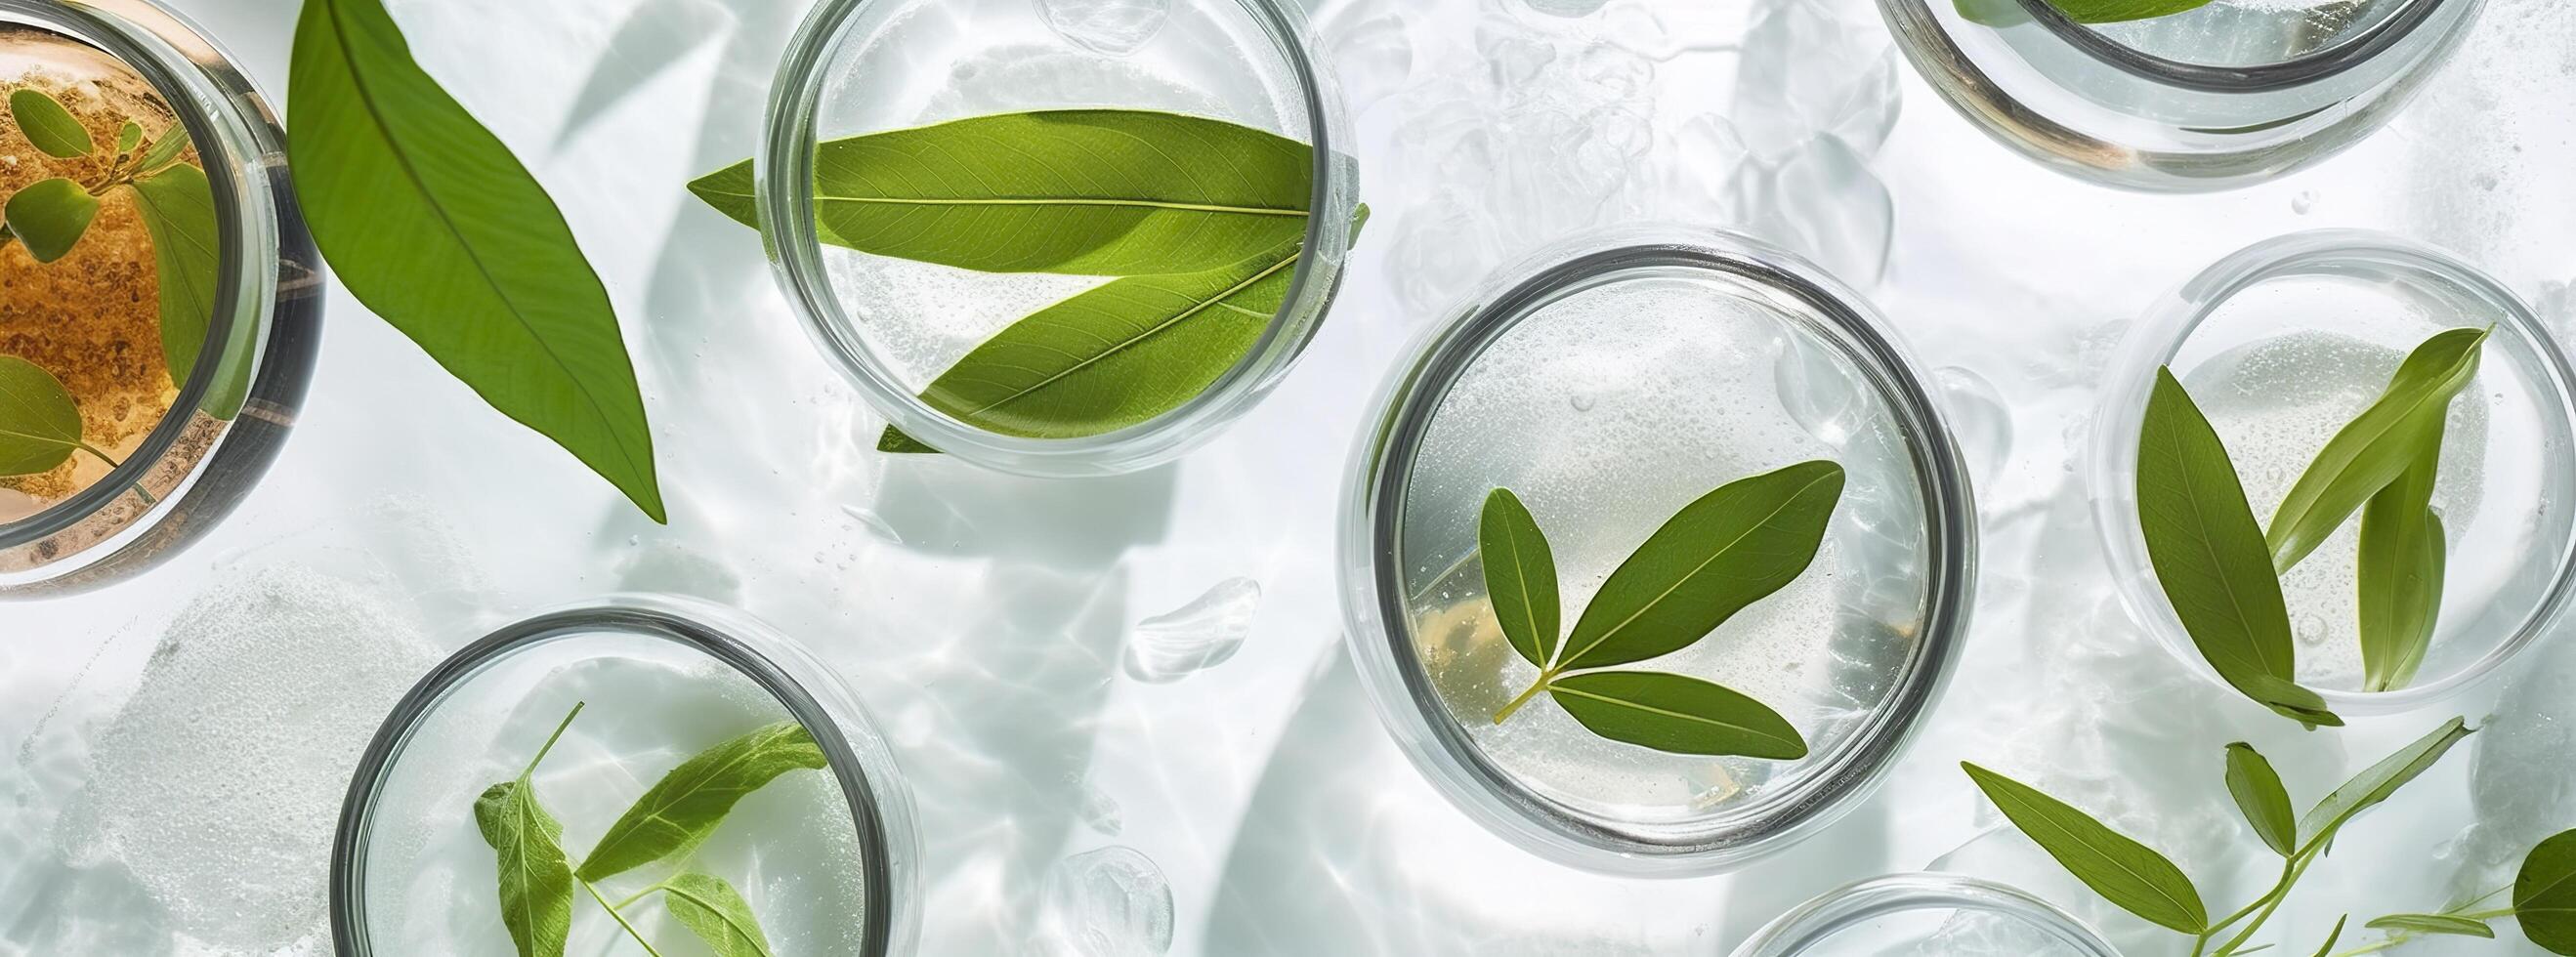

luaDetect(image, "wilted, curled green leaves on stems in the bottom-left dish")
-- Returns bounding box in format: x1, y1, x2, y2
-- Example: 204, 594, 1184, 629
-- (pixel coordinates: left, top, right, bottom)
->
474, 705, 826, 957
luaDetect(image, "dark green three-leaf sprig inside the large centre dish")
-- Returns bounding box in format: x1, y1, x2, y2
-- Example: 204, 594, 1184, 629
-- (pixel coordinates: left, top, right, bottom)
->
1476, 461, 1844, 759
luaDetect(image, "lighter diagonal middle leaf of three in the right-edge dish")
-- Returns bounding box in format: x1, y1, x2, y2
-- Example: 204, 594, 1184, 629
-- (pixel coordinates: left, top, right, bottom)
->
2264, 329, 2488, 571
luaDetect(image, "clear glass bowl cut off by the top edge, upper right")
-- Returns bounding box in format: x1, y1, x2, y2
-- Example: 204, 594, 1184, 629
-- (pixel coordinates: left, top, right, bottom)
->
1878, 0, 2480, 190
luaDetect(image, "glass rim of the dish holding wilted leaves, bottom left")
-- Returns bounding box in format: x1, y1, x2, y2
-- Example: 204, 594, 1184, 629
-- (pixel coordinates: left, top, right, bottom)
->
330, 595, 919, 957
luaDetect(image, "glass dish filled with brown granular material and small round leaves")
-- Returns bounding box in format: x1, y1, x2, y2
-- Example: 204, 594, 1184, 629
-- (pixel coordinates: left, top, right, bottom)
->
0, 0, 322, 597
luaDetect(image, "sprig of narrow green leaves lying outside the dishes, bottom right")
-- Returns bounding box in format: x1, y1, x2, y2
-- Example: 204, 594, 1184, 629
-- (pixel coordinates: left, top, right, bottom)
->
1961, 718, 2470, 954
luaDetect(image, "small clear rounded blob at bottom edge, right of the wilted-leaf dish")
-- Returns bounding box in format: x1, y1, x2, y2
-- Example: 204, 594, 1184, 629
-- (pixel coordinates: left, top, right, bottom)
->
1031, 847, 1172, 957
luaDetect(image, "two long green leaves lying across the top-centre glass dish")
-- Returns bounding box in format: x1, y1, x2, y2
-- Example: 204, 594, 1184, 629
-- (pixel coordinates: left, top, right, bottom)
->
691, 110, 1366, 453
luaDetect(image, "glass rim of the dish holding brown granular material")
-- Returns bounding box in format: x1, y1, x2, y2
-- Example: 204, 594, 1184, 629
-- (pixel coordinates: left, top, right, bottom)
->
0, 0, 319, 597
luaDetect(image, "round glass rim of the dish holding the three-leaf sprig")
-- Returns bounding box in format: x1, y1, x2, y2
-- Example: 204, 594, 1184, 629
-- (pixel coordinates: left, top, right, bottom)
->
1339, 224, 1976, 877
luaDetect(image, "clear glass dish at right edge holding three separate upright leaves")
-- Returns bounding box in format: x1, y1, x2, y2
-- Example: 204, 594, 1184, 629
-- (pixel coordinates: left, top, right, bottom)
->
2087, 229, 2576, 715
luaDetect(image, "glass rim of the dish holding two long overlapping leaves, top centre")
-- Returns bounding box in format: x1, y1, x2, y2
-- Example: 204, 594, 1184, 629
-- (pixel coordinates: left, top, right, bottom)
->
752, 0, 1342, 478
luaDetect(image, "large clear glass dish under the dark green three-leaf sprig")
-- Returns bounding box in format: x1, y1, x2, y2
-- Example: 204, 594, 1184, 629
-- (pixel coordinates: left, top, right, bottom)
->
1339, 229, 1976, 875
